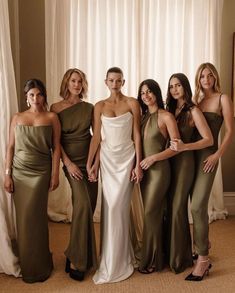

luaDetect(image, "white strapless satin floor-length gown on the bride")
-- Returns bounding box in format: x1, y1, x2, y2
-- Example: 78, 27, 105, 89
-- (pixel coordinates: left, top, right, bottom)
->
93, 112, 135, 284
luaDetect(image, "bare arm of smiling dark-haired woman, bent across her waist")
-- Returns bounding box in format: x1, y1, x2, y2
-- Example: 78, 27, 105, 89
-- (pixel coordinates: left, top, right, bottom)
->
140, 113, 180, 170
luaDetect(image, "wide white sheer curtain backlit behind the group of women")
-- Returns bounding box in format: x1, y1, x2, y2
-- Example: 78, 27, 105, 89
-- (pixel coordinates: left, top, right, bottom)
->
45, 0, 226, 220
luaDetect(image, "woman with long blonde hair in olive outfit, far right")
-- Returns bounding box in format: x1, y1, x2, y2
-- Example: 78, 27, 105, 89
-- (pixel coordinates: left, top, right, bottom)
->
183, 63, 233, 281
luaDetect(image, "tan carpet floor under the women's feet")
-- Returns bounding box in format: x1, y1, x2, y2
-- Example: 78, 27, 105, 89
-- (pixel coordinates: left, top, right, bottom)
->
0, 217, 235, 293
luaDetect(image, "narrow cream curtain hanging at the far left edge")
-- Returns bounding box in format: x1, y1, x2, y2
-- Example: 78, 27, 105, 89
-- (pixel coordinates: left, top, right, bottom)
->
0, 0, 20, 277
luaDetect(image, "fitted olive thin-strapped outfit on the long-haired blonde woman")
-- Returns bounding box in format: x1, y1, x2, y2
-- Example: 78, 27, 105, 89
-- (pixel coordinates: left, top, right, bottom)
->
191, 112, 223, 255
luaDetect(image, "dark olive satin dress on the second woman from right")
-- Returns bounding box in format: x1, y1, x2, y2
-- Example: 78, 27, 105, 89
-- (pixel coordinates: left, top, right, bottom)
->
168, 117, 195, 273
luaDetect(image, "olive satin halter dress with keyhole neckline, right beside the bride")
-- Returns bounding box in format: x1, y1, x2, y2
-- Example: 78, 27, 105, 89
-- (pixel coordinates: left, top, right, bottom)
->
139, 112, 171, 271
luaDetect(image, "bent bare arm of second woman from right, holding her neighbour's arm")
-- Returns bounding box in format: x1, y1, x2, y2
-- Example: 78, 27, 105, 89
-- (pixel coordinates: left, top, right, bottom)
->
170, 107, 213, 152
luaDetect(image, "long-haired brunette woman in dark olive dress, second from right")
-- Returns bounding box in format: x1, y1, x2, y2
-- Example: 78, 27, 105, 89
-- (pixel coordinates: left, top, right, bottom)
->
166, 73, 213, 273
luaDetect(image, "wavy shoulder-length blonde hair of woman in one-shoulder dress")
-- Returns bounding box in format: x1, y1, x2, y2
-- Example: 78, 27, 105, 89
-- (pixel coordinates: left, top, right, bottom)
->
60, 68, 88, 99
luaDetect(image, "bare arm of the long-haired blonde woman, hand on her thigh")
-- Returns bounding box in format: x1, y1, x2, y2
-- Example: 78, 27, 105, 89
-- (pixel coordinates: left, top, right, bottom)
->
203, 95, 234, 173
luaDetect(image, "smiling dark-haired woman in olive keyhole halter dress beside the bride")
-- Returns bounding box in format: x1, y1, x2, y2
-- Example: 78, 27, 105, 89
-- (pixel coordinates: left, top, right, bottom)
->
138, 79, 180, 274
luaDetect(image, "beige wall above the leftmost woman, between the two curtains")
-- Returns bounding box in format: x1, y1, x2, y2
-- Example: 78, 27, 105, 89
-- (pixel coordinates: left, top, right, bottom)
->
8, 0, 46, 110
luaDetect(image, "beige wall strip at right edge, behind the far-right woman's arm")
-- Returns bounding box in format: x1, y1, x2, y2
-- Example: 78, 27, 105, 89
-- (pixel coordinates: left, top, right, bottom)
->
220, 0, 235, 192
